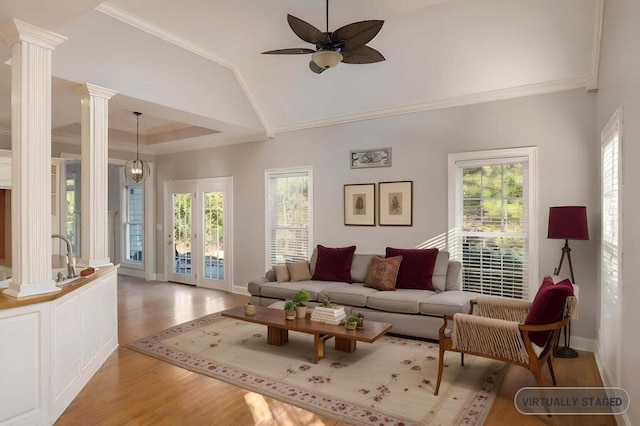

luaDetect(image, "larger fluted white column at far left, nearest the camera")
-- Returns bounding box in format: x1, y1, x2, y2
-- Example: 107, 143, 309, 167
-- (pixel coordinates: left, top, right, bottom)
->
0, 19, 66, 297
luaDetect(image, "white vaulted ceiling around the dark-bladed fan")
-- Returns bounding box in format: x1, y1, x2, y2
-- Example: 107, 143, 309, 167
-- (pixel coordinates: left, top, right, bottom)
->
0, 0, 601, 154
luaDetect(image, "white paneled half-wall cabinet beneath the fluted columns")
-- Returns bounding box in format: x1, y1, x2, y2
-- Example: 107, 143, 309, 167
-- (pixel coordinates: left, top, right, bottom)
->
0, 267, 118, 425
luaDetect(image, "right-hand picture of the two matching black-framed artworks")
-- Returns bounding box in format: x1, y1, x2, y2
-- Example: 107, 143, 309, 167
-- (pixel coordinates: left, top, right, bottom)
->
378, 181, 413, 226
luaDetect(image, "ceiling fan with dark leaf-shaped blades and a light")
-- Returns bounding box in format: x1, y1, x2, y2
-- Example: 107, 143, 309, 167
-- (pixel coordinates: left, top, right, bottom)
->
262, 0, 385, 74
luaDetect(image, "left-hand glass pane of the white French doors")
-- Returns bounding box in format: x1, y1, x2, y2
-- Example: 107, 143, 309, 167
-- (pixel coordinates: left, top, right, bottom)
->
173, 192, 191, 275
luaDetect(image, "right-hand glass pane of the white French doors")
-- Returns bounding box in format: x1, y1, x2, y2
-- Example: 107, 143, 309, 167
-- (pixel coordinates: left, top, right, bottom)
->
202, 192, 224, 280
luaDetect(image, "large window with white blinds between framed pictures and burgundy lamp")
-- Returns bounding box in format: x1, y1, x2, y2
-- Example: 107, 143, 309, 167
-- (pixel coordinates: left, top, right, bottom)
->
449, 148, 537, 300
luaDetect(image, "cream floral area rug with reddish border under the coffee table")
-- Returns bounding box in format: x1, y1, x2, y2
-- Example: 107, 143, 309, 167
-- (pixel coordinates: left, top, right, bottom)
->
125, 314, 506, 426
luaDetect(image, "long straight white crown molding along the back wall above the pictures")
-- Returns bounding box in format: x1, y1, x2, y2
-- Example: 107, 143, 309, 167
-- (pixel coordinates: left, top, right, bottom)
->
273, 77, 590, 133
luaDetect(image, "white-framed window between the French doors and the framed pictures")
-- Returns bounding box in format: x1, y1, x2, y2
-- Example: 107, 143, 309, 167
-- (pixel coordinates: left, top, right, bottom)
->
265, 167, 313, 269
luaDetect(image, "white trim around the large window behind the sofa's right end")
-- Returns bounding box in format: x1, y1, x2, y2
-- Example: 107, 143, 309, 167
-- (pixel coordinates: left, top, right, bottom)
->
447, 146, 540, 300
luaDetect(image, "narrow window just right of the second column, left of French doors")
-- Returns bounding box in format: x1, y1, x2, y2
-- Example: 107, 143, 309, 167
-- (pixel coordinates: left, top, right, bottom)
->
124, 184, 144, 266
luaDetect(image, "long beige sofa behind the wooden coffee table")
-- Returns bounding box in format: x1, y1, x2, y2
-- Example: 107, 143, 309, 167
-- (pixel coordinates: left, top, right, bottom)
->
248, 251, 480, 340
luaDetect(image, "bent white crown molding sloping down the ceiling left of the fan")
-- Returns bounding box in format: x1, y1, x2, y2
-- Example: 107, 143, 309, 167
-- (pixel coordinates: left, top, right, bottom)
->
95, 2, 273, 134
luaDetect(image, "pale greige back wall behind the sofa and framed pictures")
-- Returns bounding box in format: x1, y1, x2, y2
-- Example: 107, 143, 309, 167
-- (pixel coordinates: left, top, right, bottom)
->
156, 90, 599, 339
